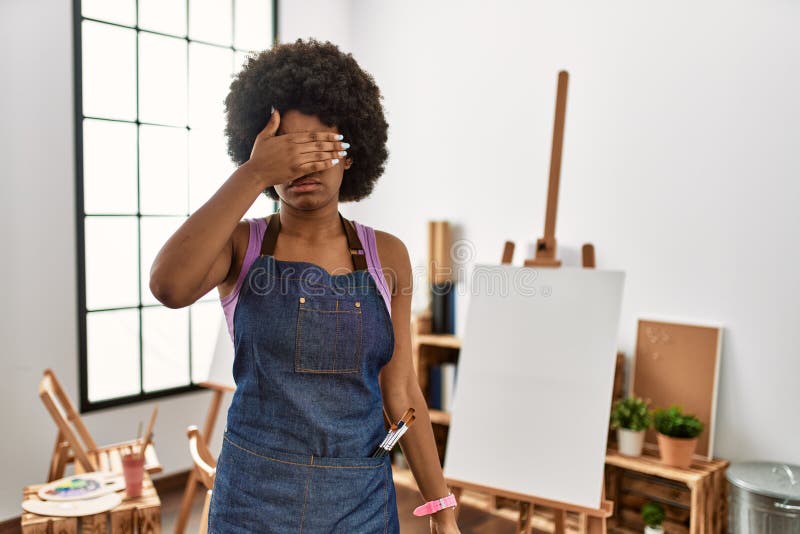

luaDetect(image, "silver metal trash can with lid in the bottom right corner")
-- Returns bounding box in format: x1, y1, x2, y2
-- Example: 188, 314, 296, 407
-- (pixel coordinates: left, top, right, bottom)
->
727, 462, 800, 534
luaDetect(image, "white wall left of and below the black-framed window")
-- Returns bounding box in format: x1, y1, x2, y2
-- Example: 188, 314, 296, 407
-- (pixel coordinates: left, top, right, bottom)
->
0, 0, 230, 521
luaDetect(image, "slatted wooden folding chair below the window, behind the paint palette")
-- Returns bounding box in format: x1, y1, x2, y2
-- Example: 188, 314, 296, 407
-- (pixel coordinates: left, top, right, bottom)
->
39, 369, 163, 482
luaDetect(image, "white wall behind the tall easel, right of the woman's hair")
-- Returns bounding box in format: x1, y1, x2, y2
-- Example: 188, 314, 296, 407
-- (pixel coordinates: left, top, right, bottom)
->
340, 0, 800, 464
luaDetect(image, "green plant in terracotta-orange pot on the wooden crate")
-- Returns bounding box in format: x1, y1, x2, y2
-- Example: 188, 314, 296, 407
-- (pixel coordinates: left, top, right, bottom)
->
653, 406, 703, 467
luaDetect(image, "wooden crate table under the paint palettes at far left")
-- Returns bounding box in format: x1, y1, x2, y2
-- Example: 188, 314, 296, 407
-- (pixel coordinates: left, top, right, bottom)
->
22, 473, 161, 534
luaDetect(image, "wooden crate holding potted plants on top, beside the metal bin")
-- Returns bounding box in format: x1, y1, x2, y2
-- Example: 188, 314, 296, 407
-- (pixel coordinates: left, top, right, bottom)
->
605, 449, 728, 534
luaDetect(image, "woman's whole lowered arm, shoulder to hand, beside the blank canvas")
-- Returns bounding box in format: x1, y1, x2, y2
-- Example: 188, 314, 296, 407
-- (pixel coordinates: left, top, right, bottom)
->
375, 232, 459, 533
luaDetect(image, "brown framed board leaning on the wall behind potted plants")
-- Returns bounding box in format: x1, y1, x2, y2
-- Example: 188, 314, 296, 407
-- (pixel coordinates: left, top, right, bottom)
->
631, 320, 722, 458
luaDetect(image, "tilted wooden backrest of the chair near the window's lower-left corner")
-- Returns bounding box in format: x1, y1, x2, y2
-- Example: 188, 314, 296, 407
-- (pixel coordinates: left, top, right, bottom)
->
39, 369, 97, 471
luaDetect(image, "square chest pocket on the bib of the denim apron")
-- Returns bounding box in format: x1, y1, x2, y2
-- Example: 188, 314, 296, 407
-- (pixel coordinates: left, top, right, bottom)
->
294, 296, 362, 373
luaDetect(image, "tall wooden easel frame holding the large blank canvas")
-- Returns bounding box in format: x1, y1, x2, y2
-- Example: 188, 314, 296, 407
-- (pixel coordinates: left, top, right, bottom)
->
445, 71, 614, 534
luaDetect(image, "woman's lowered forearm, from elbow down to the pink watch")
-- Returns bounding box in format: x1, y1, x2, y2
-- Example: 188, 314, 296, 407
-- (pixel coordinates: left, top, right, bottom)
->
386, 375, 455, 522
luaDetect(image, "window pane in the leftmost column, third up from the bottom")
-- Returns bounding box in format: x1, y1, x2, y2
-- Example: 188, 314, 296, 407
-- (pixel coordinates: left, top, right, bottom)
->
83, 119, 136, 215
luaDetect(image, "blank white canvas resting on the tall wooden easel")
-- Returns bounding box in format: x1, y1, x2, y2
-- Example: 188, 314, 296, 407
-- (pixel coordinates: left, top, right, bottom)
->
444, 265, 624, 508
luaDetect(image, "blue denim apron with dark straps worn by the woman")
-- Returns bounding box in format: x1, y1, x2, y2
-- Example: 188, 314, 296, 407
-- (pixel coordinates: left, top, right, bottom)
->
209, 213, 400, 534
